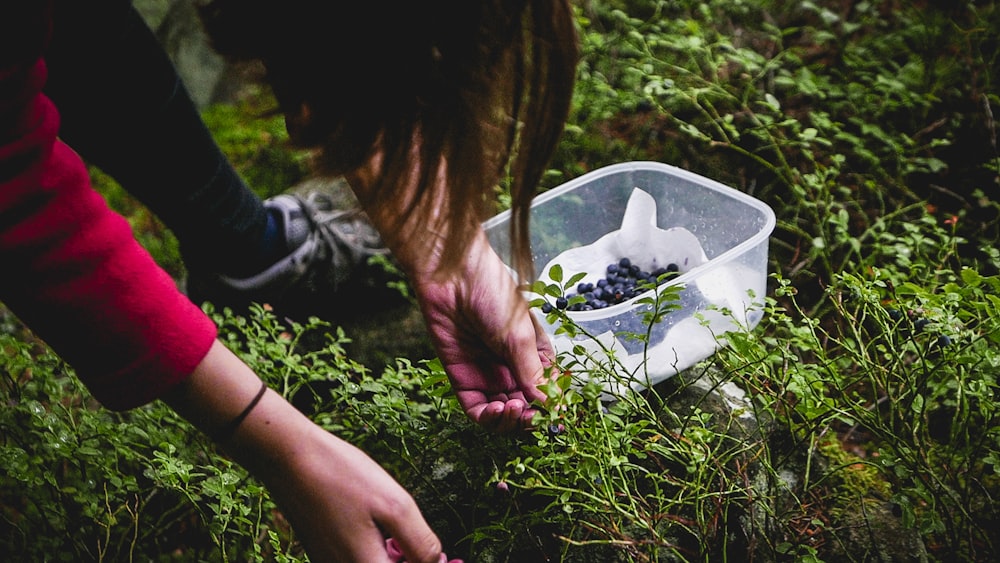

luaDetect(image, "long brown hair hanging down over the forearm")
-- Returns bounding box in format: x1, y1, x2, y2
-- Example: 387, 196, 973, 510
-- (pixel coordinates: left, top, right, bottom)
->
202, 0, 578, 275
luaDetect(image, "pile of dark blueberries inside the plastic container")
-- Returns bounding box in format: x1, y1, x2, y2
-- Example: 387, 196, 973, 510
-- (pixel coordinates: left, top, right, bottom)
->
542, 258, 680, 313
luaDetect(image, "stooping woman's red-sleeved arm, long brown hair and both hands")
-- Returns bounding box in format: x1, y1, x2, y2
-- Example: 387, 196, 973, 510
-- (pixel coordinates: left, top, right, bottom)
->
0, 0, 576, 561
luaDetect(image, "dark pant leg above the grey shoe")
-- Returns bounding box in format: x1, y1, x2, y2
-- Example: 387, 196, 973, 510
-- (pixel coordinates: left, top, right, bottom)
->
46, 0, 266, 270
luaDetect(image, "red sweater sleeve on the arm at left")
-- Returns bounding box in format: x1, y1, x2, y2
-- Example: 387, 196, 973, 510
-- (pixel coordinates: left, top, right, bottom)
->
0, 0, 216, 410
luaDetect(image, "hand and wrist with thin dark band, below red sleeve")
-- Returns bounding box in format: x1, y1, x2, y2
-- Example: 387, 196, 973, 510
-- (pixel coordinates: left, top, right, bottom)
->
170, 341, 445, 563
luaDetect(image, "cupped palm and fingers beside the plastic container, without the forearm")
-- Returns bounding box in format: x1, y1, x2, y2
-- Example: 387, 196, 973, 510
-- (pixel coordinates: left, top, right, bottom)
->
413, 231, 555, 432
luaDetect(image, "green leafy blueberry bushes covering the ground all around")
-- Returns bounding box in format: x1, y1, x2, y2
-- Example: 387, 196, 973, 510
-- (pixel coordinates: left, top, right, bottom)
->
0, 0, 1000, 562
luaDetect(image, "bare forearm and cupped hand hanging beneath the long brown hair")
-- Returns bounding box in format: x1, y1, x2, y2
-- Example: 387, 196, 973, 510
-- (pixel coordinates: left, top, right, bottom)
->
348, 152, 555, 432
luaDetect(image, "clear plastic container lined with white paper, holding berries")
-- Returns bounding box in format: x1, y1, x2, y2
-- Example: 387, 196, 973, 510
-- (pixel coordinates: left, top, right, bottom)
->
484, 162, 775, 391
